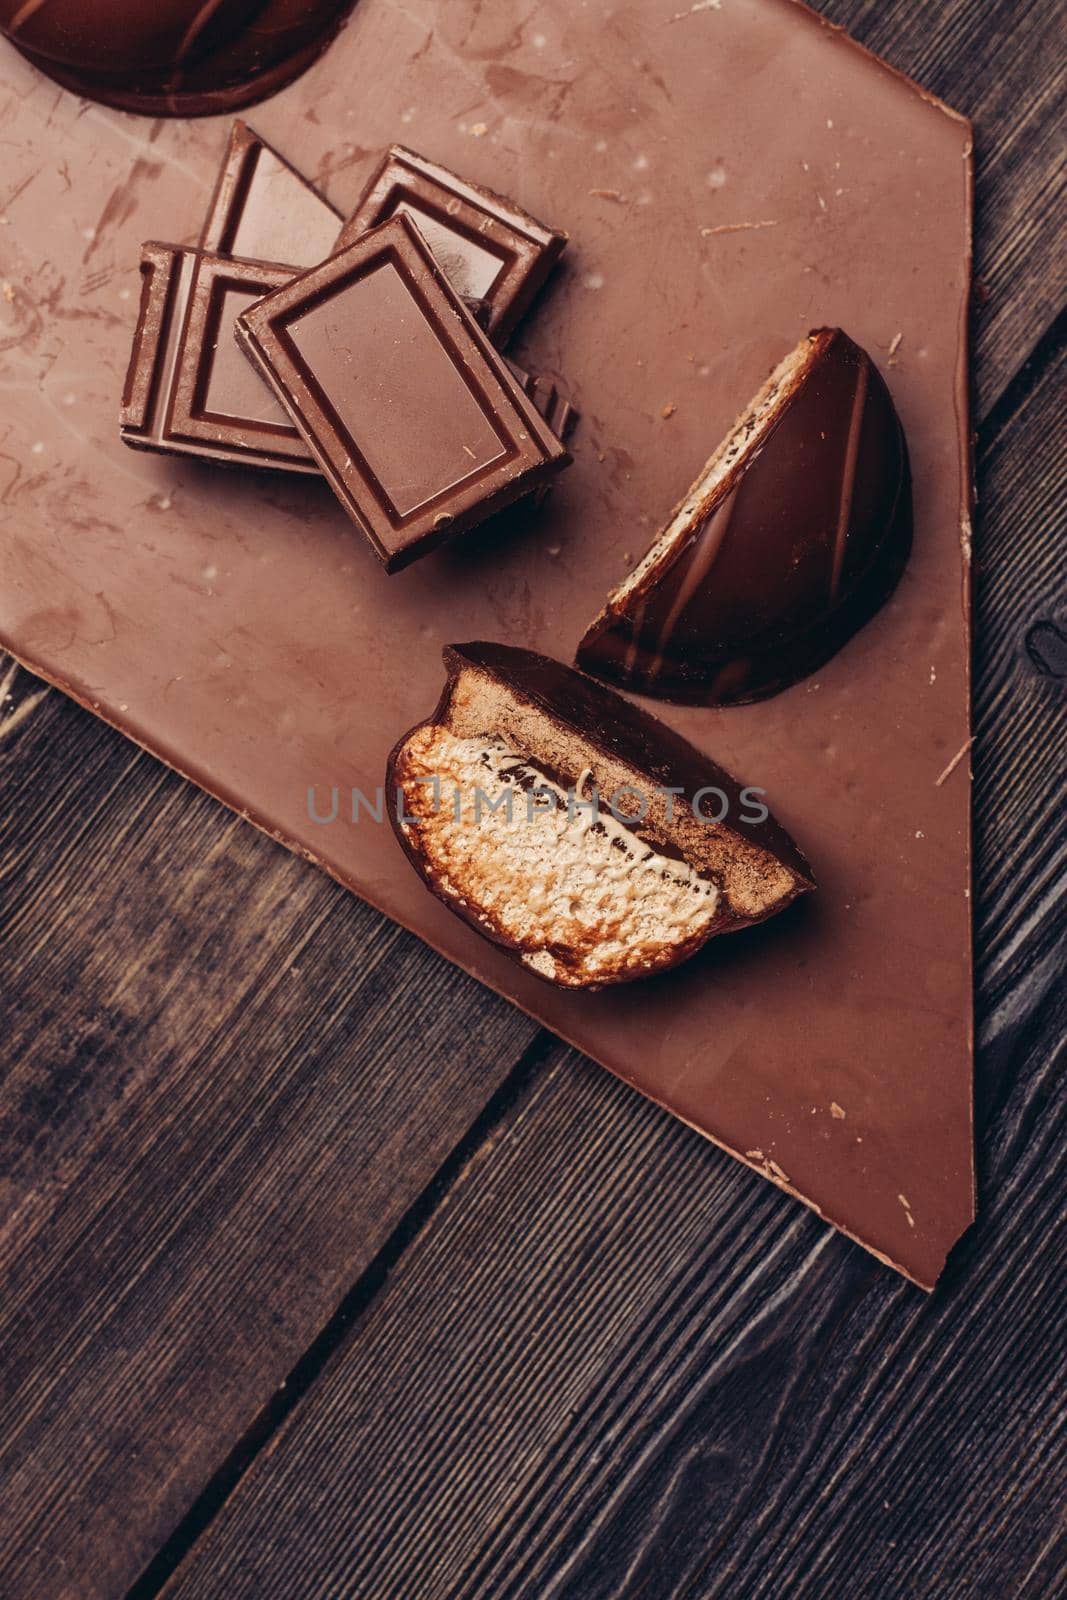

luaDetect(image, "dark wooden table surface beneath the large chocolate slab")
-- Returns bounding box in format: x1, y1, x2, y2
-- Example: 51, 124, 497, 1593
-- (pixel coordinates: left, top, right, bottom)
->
0, 0, 1067, 1600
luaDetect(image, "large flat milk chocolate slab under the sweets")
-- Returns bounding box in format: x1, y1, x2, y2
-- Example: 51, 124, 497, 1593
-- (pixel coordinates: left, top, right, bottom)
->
0, 0, 973, 1283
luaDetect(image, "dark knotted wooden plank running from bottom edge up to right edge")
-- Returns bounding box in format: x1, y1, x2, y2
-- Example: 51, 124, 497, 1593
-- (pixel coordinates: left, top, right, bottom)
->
147, 262, 1067, 1600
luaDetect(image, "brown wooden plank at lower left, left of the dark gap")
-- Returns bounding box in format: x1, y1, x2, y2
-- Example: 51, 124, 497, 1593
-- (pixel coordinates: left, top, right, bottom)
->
0, 670, 547, 1600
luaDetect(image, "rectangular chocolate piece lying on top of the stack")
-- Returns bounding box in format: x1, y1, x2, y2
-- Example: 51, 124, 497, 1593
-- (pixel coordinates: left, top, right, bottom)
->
237, 216, 569, 571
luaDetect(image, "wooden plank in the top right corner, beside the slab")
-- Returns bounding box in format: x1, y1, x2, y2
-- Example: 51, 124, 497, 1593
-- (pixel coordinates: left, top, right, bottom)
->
817, 0, 1067, 418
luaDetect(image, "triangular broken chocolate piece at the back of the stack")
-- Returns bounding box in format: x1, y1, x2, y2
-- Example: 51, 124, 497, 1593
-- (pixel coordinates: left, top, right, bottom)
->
200, 118, 342, 270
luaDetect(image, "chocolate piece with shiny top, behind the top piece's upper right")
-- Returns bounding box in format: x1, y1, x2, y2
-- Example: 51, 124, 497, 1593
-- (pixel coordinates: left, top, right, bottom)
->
341, 144, 566, 344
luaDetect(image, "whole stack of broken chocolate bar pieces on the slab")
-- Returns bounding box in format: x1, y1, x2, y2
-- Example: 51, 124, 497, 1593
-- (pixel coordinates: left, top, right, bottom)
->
122, 122, 576, 571
